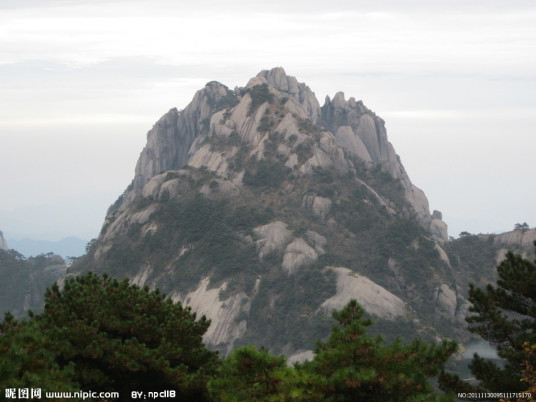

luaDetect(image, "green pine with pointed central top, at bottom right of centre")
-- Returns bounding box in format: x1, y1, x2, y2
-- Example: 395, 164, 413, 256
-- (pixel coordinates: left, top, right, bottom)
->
303, 300, 457, 401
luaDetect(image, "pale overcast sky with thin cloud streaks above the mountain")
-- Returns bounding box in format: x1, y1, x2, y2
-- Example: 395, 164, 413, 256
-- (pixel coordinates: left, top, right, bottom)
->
0, 0, 536, 241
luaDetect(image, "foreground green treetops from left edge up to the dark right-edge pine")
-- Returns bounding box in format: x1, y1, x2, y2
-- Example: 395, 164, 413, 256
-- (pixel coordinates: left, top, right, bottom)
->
0, 273, 456, 401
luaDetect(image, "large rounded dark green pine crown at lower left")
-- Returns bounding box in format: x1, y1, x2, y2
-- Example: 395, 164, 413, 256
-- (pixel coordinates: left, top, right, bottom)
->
0, 273, 218, 401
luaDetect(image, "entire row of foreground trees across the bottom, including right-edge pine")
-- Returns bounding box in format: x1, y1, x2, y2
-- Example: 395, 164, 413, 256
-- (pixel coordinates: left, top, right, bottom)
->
0, 244, 536, 401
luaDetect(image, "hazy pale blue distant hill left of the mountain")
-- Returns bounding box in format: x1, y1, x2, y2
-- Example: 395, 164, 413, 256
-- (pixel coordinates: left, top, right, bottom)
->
9, 237, 88, 258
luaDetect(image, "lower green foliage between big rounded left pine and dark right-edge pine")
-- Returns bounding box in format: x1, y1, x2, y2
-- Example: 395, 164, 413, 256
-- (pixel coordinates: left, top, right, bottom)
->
209, 300, 457, 402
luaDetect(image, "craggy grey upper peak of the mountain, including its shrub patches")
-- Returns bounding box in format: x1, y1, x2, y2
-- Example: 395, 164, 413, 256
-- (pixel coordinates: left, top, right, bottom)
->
112, 67, 447, 241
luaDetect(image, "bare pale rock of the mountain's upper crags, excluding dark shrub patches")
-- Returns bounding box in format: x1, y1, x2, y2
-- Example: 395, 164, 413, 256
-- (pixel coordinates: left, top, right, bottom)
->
112, 67, 448, 241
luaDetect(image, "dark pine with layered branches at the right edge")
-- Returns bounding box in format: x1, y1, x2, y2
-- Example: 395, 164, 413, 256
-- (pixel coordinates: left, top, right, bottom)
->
467, 242, 536, 392
